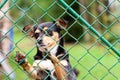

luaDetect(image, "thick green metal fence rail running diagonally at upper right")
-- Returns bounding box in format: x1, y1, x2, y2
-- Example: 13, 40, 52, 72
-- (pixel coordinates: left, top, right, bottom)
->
58, 0, 120, 57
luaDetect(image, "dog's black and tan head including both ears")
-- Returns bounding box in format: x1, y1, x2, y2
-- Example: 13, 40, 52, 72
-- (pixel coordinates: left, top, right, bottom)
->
23, 19, 67, 51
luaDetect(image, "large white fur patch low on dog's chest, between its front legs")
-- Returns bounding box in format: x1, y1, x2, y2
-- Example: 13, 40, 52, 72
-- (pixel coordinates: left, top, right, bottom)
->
33, 59, 54, 71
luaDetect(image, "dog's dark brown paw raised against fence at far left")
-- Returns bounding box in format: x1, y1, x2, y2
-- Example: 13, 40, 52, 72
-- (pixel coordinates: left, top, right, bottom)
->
15, 51, 26, 65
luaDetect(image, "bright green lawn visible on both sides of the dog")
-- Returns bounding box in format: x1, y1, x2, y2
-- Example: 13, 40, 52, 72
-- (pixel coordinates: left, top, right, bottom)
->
3, 30, 120, 80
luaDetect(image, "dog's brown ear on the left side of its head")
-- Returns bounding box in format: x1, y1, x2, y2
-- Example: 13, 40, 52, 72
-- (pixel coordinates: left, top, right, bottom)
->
23, 25, 35, 37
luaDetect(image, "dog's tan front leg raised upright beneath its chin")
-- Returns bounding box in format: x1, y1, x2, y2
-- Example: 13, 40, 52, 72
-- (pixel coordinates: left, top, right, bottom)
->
49, 54, 68, 80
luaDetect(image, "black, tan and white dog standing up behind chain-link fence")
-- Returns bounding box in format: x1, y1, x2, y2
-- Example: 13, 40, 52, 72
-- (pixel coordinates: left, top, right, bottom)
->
15, 19, 77, 80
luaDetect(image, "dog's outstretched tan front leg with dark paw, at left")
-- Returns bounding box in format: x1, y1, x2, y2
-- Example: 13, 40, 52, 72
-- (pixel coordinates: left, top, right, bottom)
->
15, 51, 37, 80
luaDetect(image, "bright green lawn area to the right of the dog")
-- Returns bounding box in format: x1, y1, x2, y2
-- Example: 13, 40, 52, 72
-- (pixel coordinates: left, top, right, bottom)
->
66, 43, 120, 80
